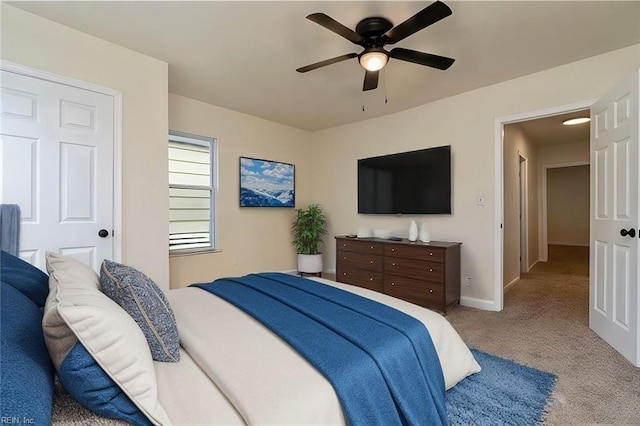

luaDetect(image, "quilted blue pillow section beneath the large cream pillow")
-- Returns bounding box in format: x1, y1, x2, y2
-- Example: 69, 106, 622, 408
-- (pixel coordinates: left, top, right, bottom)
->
58, 342, 151, 425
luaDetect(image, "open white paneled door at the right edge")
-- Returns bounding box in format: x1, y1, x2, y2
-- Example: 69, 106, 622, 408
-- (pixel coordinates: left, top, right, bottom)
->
589, 72, 640, 366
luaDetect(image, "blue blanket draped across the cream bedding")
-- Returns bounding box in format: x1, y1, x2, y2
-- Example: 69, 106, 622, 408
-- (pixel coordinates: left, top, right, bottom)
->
194, 273, 447, 426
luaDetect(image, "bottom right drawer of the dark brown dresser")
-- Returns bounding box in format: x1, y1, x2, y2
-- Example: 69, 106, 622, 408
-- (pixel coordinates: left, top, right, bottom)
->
384, 275, 444, 310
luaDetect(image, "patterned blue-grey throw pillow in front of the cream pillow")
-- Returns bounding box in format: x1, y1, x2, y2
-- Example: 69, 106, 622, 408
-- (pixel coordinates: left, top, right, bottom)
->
100, 260, 180, 362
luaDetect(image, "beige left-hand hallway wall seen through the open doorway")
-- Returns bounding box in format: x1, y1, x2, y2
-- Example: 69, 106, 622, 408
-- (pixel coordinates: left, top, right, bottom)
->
502, 124, 539, 286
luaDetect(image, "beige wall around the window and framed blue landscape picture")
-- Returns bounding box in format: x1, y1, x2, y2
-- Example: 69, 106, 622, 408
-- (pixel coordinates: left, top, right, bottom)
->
169, 94, 313, 288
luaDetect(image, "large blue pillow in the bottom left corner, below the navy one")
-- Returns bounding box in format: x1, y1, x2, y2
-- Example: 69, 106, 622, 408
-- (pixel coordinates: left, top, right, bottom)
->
0, 282, 54, 425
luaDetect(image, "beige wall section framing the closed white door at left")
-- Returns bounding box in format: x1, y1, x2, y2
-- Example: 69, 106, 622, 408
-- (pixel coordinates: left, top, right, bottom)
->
0, 3, 169, 288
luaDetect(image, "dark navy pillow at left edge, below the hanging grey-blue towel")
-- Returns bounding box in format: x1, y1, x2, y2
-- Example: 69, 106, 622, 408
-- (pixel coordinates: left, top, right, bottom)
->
0, 250, 49, 308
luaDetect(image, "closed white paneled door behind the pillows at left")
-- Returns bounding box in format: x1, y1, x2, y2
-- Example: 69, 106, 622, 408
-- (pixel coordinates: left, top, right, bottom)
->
0, 70, 114, 270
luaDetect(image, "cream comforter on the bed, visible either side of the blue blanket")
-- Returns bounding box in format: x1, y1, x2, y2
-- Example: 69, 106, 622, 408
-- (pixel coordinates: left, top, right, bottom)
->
160, 278, 480, 425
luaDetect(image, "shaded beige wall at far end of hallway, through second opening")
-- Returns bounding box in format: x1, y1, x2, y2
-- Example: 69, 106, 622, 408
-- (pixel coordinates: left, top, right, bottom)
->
547, 166, 589, 246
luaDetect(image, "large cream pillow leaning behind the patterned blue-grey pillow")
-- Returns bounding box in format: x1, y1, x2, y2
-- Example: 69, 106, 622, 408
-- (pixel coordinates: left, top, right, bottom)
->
42, 253, 171, 425
